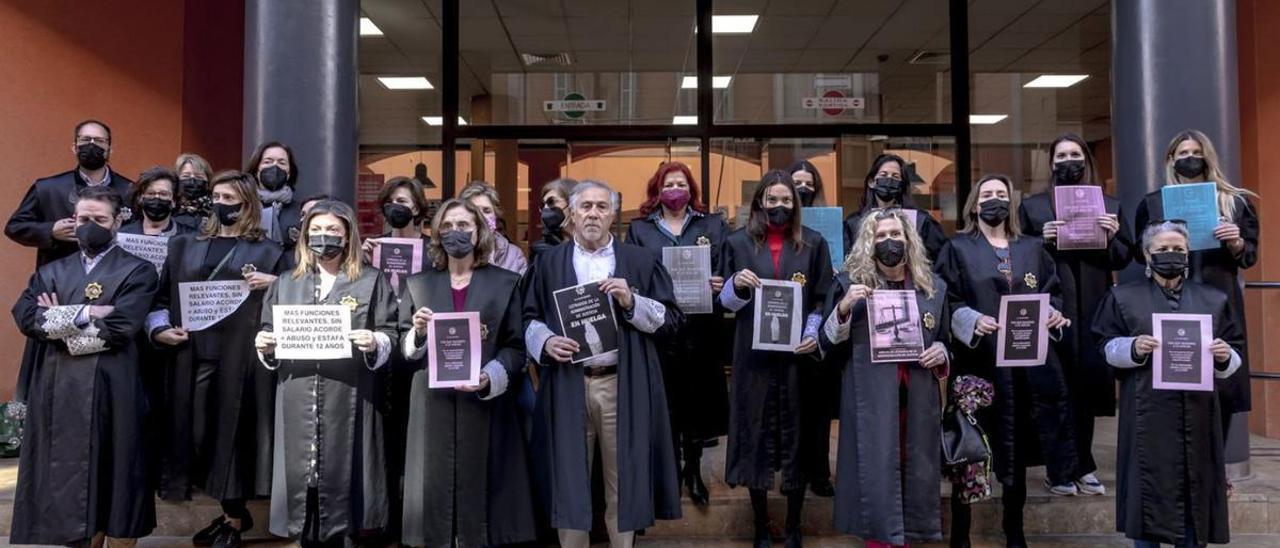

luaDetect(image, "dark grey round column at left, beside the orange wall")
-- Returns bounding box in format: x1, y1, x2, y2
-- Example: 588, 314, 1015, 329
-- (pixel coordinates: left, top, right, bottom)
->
243, 0, 360, 204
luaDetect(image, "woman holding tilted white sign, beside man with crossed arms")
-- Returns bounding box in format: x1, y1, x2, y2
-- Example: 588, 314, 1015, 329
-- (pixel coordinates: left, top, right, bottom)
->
147, 172, 291, 545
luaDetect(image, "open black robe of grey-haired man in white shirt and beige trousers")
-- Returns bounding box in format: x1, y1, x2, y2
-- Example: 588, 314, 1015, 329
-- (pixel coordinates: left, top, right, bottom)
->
524, 238, 684, 531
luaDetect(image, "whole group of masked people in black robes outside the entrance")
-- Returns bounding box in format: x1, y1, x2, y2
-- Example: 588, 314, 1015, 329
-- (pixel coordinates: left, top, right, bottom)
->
5, 120, 1258, 547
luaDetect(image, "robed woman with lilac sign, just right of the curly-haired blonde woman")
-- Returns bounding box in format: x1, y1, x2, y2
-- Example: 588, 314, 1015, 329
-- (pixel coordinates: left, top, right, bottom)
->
934, 175, 1076, 547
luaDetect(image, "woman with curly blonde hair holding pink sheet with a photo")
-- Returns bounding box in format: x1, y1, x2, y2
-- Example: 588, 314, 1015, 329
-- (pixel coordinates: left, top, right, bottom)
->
820, 209, 950, 548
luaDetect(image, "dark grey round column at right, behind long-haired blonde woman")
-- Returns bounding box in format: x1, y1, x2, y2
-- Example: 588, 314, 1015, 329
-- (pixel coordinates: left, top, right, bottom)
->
1111, 0, 1262, 478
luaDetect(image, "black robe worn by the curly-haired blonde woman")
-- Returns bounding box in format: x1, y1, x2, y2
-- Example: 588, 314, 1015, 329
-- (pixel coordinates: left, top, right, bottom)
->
819, 273, 951, 544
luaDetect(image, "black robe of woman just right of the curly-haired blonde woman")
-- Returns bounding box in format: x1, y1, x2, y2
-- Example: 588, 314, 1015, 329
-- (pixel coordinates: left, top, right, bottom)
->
934, 232, 1078, 485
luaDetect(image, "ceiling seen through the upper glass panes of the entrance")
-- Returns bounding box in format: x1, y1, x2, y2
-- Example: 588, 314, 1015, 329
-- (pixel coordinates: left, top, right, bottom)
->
358, 0, 1111, 143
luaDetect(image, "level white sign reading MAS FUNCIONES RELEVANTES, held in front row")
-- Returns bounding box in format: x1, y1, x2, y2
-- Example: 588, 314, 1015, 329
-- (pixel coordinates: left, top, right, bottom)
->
271, 305, 351, 360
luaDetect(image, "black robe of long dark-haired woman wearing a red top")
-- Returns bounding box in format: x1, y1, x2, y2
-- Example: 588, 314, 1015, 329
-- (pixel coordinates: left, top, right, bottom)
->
721, 228, 835, 492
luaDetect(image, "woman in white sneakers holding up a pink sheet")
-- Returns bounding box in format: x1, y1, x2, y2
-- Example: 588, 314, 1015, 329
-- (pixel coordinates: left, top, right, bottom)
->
1018, 133, 1133, 496
